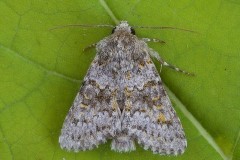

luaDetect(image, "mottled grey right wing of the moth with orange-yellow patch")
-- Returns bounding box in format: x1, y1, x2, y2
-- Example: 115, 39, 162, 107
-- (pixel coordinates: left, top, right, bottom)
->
122, 56, 187, 155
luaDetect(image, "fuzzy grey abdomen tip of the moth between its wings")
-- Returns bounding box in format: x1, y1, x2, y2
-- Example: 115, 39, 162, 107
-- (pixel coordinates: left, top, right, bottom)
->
111, 136, 136, 152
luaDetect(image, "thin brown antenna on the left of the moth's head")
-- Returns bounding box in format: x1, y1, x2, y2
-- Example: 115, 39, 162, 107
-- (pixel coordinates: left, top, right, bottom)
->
49, 24, 115, 31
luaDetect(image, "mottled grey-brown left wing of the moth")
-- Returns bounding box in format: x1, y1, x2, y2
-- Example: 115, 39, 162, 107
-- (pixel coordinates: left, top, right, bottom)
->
59, 56, 121, 152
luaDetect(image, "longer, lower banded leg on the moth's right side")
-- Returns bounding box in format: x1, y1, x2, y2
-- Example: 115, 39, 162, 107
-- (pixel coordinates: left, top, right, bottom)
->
149, 49, 194, 76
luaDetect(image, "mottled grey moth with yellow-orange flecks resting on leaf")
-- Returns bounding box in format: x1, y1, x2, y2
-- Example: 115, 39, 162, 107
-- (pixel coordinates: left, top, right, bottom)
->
59, 21, 188, 155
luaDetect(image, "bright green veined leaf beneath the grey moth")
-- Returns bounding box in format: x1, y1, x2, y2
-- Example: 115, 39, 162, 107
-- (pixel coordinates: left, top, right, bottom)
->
0, 0, 240, 160
